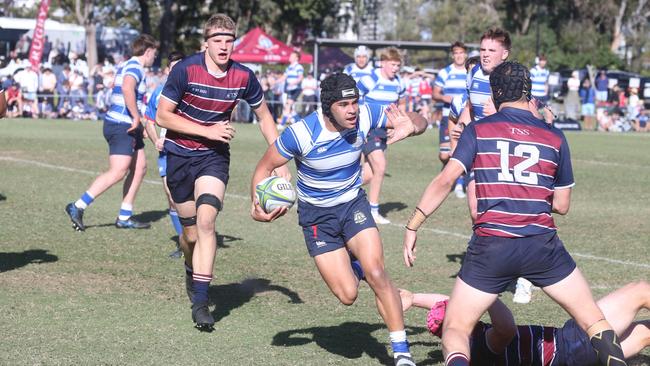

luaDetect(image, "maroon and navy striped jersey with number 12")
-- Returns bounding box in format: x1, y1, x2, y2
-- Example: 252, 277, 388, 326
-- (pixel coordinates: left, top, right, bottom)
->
452, 108, 574, 238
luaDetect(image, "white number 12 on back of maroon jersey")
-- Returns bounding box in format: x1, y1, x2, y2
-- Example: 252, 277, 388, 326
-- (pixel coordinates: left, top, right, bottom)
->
497, 141, 539, 184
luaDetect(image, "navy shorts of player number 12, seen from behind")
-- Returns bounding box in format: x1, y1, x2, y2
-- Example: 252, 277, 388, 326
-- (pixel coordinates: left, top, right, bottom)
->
458, 232, 576, 294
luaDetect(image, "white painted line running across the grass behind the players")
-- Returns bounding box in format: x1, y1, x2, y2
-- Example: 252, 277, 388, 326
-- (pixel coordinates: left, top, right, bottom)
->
0, 156, 650, 269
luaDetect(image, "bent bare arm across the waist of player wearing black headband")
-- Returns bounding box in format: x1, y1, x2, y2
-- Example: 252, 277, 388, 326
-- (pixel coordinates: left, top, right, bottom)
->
156, 98, 235, 142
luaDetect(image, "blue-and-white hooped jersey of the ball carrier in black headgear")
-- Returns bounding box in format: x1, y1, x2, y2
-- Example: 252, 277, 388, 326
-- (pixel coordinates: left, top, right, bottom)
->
275, 104, 386, 207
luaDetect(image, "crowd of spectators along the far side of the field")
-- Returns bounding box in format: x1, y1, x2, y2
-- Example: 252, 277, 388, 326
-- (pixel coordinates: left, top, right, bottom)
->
0, 37, 650, 132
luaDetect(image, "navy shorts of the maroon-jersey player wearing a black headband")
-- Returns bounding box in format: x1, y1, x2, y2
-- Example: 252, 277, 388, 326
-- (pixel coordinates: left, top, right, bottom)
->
167, 148, 230, 203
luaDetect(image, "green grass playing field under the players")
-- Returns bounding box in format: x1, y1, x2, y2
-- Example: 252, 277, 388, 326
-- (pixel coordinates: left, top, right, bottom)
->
0, 119, 650, 365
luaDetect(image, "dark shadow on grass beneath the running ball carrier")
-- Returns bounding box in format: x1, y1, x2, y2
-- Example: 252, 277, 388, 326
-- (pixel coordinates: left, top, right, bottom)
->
271, 322, 432, 365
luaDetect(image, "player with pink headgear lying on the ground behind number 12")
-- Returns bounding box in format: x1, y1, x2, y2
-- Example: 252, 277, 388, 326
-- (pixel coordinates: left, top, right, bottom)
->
400, 281, 650, 366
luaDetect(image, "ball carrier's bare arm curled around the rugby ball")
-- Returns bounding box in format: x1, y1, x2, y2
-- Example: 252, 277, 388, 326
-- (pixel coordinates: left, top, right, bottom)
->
250, 144, 289, 222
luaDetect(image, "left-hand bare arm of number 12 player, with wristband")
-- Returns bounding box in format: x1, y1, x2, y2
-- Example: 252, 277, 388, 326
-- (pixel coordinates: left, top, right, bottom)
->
403, 160, 465, 267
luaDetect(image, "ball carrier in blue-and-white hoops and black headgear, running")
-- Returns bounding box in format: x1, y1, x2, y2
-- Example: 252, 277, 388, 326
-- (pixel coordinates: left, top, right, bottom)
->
251, 74, 426, 365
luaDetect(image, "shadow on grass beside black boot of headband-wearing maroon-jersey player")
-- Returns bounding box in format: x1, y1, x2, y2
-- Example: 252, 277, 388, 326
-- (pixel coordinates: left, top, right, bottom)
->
208, 278, 303, 322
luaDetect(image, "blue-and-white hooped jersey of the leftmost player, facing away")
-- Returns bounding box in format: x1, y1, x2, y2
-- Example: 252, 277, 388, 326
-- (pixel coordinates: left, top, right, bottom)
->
104, 56, 147, 123
